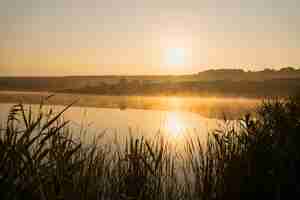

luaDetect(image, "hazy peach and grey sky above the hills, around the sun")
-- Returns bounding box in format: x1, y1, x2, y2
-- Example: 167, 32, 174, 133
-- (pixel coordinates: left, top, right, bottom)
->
0, 0, 300, 75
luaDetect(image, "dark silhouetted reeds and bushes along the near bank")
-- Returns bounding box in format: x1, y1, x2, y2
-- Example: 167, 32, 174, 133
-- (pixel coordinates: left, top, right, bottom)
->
0, 98, 300, 200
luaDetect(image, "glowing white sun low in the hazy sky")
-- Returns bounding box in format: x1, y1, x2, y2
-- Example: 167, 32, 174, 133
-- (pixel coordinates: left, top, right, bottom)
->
164, 47, 186, 66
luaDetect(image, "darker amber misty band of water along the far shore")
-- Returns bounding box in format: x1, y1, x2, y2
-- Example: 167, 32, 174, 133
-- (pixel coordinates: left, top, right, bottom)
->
0, 91, 260, 119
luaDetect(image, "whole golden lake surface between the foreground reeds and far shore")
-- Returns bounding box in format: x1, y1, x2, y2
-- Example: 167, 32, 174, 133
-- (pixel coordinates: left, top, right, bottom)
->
0, 93, 258, 145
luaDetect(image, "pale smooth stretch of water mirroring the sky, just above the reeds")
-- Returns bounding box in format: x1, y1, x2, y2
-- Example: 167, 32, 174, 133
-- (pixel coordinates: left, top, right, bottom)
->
0, 103, 223, 144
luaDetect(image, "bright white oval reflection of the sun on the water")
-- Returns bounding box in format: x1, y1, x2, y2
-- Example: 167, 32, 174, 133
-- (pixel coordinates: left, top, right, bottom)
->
165, 112, 186, 137
